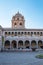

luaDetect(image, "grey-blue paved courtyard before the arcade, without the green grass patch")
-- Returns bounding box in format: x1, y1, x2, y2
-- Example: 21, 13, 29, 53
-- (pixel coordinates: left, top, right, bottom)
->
0, 52, 43, 65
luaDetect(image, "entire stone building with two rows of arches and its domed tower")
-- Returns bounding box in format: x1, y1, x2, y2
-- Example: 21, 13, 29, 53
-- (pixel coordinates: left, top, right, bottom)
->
0, 12, 43, 50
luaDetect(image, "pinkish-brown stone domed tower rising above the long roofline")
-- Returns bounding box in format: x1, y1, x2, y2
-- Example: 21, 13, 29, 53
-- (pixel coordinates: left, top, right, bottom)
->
12, 12, 25, 28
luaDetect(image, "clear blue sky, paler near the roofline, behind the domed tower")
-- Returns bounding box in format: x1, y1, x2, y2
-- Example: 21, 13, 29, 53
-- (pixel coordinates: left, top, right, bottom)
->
0, 0, 43, 28
